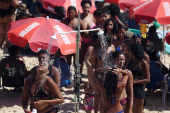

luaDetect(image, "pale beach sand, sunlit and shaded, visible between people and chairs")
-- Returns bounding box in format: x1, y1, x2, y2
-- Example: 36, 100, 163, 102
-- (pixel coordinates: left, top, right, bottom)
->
0, 49, 170, 113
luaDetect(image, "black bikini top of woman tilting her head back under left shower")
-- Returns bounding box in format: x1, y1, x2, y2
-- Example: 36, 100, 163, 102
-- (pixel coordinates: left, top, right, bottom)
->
28, 77, 48, 97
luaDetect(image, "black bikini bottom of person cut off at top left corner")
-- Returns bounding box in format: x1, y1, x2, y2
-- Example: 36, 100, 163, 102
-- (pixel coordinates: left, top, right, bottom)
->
0, 0, 14, 18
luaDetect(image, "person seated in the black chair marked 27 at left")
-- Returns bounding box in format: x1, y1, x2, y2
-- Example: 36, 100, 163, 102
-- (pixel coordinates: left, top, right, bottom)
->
1, 45, 30, 78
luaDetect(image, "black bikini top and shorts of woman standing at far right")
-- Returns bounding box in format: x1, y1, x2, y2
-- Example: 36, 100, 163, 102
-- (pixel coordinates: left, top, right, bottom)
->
127, 60, 145, 99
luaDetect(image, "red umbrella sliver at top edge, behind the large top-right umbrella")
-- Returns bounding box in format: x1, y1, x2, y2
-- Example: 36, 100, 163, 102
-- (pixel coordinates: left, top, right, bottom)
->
119, 0, 148, 12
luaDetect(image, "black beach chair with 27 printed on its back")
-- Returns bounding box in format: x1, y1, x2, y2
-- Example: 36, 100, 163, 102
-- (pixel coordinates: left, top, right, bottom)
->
0, 56, 25, 88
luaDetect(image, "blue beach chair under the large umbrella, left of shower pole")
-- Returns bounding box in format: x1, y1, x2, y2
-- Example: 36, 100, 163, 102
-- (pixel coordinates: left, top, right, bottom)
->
52, 57, 71, 87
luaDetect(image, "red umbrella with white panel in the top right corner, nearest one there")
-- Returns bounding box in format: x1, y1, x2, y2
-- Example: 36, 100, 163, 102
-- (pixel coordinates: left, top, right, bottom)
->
129, 0, 170, 25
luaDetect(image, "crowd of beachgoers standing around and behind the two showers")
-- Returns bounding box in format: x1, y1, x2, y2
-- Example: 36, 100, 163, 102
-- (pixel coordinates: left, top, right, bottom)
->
0, 0, 168, 113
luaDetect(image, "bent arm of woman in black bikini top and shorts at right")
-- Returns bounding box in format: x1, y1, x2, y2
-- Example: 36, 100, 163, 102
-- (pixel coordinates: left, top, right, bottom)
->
133, 59, 150, 84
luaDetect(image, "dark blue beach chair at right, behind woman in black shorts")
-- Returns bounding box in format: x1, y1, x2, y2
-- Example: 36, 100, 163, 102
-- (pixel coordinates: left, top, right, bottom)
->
146, 61, 163, 89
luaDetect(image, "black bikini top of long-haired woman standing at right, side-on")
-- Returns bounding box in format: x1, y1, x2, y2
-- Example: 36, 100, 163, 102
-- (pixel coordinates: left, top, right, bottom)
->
127, 60, 143, 76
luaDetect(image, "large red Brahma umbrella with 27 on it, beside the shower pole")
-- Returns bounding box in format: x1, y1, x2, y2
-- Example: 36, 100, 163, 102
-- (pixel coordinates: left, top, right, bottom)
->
8, 17, 76, 55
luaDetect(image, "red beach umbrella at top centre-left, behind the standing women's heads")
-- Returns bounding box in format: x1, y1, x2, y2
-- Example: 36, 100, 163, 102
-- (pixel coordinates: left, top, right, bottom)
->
42, 0, 96, 14
